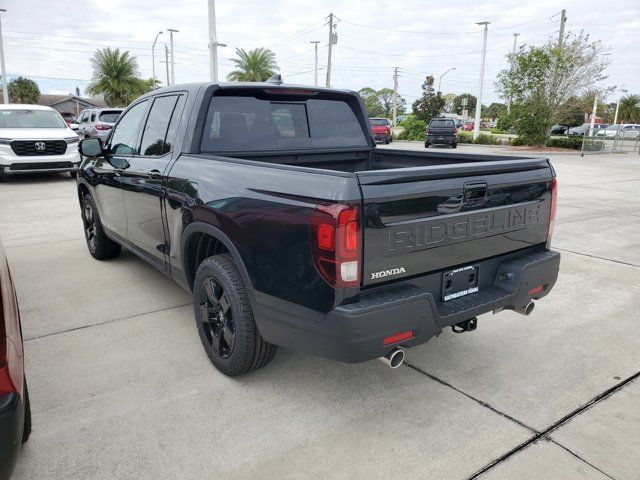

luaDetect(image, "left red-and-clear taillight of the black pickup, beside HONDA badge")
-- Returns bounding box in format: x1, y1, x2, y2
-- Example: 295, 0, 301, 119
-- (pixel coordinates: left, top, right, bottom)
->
311, 204, 362, 288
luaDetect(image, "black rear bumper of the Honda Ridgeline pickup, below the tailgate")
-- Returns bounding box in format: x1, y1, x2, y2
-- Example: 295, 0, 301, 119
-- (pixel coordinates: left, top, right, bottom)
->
255, 251, 560, 363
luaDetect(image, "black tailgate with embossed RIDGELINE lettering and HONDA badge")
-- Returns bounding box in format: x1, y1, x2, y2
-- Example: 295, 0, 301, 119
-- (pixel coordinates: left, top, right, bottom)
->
356, 158, 553, 286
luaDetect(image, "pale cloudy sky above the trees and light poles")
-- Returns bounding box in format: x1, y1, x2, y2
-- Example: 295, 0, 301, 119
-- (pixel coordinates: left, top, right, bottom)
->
0, 0, 640, 104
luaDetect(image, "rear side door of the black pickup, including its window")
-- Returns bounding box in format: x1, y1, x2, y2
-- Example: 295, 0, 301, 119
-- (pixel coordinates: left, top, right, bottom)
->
123, 94, 184, 269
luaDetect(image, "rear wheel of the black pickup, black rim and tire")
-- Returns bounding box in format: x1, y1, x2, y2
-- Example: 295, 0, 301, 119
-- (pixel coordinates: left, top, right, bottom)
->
193, 254, 278, 377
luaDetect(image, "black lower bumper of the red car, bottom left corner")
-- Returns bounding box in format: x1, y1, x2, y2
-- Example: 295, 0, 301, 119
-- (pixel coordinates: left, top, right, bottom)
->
0, 393, 24, 480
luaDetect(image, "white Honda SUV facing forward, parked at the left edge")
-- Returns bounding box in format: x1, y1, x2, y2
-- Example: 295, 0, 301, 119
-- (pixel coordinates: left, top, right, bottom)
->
0, 105, 80, 182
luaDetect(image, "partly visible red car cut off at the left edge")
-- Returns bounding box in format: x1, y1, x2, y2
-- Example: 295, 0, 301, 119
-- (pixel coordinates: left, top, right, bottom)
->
0, 235, 31, 480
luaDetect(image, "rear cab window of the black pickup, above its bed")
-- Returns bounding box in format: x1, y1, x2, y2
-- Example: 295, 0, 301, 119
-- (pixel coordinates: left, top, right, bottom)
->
201, 96, 367, 152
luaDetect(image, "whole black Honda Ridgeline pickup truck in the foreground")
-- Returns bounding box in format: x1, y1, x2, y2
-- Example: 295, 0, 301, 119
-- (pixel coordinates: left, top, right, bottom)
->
78, 81, 560, 375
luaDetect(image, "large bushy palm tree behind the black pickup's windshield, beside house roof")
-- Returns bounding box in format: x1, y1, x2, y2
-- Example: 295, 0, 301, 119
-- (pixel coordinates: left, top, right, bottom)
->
87, 48, 151, 107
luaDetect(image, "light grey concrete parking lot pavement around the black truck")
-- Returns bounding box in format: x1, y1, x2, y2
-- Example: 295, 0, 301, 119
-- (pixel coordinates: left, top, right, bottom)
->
0, 142, 640, 480
